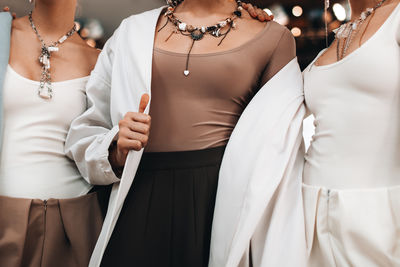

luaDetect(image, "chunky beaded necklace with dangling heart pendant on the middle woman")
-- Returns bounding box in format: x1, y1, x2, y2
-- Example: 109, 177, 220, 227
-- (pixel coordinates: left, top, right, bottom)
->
158, 0, 243, 76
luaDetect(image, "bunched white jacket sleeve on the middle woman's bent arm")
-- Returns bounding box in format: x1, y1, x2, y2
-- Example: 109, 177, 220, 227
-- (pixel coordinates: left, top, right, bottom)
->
65, 26, 120, 185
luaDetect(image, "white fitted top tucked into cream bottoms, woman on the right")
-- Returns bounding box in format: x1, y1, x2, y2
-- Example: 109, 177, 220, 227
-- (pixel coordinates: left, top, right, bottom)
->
304, 5, 400, 189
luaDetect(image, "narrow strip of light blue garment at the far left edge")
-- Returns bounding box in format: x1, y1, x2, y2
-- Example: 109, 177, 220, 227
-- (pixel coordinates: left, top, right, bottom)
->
0, 12, 12, 154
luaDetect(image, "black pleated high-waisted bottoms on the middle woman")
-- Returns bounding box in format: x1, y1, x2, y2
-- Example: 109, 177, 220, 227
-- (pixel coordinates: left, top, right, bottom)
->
101, 147, 225, 267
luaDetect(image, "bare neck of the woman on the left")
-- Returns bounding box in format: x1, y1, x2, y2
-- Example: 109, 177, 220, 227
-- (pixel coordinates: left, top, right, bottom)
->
32, 0, 77, 38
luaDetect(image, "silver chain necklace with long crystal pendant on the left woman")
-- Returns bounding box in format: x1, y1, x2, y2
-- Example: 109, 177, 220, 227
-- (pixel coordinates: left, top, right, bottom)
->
28, 12, 76, 99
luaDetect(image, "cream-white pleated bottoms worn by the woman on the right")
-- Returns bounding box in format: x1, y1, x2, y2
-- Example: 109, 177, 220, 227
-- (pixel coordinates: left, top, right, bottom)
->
303, 185, 400, 267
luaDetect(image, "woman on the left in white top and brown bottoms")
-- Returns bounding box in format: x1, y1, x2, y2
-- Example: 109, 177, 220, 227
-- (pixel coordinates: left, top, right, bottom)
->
0, 0, 153, 267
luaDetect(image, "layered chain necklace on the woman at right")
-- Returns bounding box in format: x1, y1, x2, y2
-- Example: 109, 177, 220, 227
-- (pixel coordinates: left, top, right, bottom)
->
334, 0, 386, 61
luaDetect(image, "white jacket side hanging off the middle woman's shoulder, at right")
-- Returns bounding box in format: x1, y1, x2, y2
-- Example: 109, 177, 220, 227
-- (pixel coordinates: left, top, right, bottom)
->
209, 59, 306, 267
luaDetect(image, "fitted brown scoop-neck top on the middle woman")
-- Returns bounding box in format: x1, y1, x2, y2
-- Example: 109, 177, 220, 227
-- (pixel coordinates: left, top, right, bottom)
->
146, 22, 295, 152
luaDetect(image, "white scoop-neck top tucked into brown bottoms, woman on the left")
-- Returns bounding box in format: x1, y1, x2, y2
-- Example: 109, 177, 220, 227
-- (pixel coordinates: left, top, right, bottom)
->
0, 66, 91, 199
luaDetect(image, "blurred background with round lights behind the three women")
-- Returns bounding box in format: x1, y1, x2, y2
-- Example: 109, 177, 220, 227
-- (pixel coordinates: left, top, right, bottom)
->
0, 0, 350, 69
